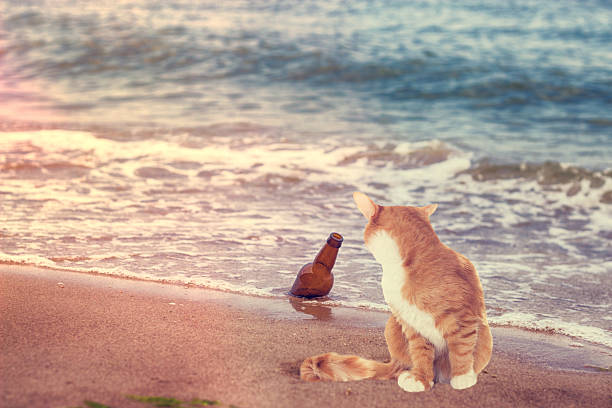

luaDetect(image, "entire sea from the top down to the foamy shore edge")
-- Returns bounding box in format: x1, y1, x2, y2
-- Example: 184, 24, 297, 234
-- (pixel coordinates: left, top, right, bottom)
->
0, 0, 612, 346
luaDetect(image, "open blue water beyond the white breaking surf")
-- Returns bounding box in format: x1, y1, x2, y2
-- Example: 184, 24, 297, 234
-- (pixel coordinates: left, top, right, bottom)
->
0, 0, 612, 168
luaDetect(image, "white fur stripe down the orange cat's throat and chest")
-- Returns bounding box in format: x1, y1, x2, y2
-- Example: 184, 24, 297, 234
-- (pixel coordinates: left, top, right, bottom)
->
367, 231, 446, 354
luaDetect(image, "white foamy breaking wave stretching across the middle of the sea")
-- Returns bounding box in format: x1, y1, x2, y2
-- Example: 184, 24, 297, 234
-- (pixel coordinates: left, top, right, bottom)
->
0, 130, 612, 205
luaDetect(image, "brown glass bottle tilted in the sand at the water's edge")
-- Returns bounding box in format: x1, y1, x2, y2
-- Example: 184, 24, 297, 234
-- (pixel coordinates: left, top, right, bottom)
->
291, 232, 344, 298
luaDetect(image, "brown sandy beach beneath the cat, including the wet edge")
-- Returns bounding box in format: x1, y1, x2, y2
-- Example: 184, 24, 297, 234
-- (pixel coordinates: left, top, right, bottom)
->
0, 266, 612, 408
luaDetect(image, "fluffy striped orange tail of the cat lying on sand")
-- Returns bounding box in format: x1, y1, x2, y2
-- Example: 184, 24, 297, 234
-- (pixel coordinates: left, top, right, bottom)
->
300, 353, 405, 381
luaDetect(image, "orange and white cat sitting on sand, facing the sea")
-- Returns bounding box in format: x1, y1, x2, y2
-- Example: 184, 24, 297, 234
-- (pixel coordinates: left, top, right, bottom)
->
300, 192, 493, 392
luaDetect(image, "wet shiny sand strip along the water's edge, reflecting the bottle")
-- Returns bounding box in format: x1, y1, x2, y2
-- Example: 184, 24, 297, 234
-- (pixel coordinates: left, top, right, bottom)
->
0, 264, 612, 372
